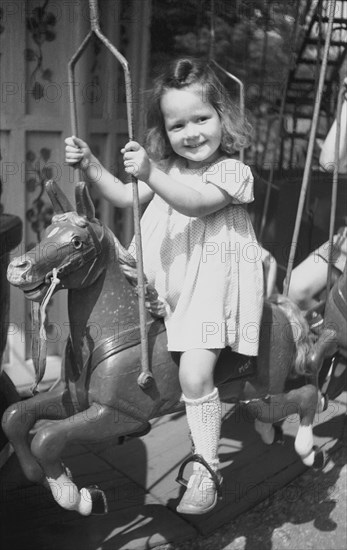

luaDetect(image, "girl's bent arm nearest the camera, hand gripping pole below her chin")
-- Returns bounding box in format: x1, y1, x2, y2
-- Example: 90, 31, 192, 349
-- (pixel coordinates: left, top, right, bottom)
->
122, 141, 231, 217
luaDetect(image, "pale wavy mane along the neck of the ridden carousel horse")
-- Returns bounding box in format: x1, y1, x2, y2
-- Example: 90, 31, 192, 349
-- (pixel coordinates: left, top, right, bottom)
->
113, 235, 165, 317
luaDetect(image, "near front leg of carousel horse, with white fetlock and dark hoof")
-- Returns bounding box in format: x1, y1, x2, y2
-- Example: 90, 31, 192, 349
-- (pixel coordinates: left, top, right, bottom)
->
31, 403, 143, 515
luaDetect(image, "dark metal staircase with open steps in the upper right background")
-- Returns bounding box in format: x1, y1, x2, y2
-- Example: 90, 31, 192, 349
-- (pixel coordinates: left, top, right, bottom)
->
279, 0, 347, 169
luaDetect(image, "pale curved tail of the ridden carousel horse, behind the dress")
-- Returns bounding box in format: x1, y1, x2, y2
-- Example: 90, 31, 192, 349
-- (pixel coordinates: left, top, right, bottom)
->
270, 294, 314, 376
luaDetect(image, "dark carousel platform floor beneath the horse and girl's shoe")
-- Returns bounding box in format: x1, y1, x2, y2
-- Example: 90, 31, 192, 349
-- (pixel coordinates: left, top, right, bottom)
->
0, 391, 347, 550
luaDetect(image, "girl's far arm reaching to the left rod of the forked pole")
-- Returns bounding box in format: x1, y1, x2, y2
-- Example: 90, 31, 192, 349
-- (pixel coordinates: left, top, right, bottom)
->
65, 136, 153, 208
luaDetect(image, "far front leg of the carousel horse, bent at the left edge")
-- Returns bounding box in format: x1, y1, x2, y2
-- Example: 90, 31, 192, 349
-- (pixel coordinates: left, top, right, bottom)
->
2, 386, 67, 483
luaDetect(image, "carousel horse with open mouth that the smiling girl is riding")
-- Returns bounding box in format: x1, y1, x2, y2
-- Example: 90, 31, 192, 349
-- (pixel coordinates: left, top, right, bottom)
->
2, 181, 334, 515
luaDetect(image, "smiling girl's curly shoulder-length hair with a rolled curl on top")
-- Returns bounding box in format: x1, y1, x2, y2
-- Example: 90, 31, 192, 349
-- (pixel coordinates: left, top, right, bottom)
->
146, 57, 252, 161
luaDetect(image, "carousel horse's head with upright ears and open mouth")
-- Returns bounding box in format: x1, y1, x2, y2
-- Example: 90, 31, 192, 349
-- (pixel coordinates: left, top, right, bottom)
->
7, 180, 109, 302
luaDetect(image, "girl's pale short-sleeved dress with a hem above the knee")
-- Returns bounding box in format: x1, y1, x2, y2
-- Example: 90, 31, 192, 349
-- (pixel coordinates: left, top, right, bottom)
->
134, 159, 263, 355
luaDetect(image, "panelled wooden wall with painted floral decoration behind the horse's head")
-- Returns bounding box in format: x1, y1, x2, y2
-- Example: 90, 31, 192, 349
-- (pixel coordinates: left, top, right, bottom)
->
0, 0, 150, 386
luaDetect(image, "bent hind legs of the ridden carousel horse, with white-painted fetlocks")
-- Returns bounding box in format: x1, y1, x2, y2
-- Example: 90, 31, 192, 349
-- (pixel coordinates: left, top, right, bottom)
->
246, 384, 323, 467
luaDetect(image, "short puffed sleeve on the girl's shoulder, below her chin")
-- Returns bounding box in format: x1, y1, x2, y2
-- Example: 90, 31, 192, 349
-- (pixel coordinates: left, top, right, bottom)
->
203, 159, 254, 204
